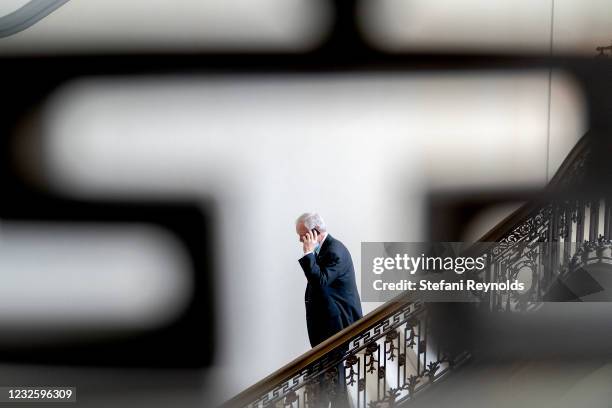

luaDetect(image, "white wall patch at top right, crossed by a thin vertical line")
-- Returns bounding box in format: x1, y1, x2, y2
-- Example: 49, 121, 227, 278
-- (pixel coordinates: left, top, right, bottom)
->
360, 0, 612, 57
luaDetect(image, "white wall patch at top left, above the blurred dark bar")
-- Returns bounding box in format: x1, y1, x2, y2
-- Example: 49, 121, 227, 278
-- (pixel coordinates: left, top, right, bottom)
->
0, 0, 331, 55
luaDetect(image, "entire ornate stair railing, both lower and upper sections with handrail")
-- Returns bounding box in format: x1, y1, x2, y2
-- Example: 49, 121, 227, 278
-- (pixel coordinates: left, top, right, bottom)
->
225, 137, 592, 408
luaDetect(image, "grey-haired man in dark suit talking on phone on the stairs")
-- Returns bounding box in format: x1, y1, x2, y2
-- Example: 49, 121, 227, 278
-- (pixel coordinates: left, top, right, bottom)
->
295, 213, 363, 406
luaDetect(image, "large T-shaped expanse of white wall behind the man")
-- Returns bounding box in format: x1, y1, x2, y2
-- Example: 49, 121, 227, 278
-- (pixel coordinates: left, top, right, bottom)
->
37, 72, 583, 399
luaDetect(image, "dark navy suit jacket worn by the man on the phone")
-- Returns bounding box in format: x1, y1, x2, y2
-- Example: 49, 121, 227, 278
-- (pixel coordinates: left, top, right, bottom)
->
299, 234, 363, 347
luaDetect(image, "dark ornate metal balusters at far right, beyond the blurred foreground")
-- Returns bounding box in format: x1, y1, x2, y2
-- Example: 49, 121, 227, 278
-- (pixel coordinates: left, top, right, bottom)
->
464, 198, 612, 312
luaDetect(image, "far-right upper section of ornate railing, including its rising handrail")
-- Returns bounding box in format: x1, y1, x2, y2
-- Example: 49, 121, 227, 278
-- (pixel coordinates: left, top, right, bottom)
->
464, 137, 612, 312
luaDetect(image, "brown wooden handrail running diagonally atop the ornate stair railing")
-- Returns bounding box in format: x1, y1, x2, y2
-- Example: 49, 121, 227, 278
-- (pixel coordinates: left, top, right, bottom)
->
222, 135, 588, 408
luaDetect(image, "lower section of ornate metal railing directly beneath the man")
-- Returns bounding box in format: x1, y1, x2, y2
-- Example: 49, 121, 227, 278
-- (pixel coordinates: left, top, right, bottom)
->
225, 301, 469, 407
